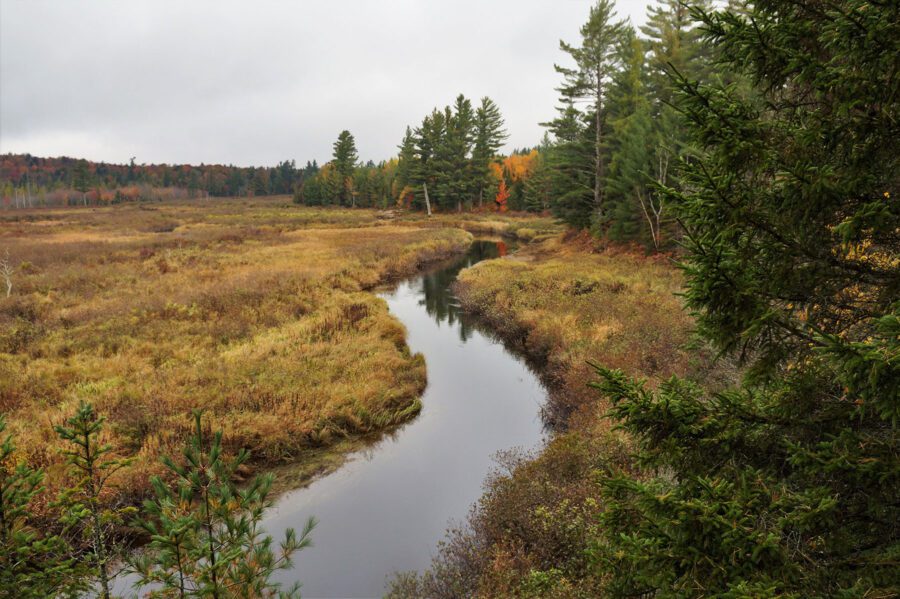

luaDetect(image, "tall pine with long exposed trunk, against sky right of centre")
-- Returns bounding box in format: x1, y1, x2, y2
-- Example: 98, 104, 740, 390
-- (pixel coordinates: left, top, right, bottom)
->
556, 0, 624, 227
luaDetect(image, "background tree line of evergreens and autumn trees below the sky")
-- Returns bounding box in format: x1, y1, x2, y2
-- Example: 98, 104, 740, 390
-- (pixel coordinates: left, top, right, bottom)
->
0, 0, 724, 254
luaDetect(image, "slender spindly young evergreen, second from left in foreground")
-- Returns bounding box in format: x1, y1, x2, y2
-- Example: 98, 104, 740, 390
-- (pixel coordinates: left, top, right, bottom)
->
55, 402, 135, 599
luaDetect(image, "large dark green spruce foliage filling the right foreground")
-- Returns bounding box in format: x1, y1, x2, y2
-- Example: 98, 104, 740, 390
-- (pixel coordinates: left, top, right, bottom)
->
595, 1, 900, 597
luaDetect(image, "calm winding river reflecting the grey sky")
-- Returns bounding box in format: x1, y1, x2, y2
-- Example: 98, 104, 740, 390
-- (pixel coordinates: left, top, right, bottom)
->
112, 241, 546, 599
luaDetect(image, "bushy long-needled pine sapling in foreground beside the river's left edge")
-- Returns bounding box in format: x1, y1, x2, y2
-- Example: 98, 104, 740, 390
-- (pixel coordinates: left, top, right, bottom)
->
131, 412, 315, 599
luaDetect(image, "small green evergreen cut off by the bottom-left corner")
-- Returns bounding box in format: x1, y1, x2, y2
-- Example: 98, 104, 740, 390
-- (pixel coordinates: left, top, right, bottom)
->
0, 416, 87, 599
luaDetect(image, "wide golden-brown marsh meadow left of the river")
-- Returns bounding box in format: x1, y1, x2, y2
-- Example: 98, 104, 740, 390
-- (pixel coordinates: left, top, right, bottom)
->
0, 200, 472, 508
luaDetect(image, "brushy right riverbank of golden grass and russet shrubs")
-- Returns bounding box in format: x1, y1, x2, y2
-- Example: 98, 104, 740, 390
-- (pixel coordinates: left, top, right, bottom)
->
390, 236, 733, 598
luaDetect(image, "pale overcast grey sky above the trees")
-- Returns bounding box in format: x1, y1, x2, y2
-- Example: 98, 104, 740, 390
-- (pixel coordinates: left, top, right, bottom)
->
0, 0, 647, 166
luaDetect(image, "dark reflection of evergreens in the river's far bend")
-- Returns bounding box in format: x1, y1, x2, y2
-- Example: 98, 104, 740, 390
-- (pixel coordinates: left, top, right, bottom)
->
419, 241, 506, 341
